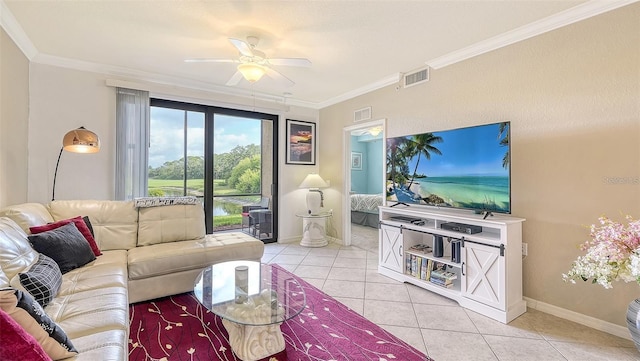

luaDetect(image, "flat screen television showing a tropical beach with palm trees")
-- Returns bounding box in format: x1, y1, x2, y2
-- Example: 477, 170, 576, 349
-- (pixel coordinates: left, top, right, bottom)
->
386, 122, 511, 213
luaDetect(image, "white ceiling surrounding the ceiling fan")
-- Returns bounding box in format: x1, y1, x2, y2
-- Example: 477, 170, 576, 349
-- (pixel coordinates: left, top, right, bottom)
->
0, 0, 635, 108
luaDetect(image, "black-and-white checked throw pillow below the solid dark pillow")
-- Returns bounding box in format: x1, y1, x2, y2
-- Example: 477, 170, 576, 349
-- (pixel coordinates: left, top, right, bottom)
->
18, 253, 62, 307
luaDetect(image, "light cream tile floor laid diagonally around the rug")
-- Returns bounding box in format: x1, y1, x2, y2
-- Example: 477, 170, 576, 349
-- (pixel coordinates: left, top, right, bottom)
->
262, 225, 640, 361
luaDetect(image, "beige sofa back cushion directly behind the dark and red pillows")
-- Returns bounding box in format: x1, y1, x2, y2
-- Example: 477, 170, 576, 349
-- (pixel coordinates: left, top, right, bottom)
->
48, 200, 138, 251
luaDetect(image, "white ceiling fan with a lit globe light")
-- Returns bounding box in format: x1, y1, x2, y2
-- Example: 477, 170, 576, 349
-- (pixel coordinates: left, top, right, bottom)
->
185, 36, 311, 86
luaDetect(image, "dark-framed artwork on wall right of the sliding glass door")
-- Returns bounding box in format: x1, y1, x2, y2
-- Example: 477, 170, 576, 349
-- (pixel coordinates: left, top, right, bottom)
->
286, 119, 316, 165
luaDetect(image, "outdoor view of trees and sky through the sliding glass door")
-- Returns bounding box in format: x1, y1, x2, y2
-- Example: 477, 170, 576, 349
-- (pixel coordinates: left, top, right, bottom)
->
148, 106, 262, 230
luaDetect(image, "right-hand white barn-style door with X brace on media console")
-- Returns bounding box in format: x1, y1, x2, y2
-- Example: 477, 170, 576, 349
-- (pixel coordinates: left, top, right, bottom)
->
461, 242, 506, 311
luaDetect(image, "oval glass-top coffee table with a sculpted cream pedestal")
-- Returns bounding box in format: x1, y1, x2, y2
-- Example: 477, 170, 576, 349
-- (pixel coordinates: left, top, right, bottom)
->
193, 261, 306, 361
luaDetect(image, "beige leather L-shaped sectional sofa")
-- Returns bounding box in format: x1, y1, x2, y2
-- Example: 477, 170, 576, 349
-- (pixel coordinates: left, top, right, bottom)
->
0, 200, 264, 360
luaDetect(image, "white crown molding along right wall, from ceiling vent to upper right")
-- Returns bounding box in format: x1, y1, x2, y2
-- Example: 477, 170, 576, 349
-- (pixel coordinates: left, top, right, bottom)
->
426, 0, 639, 69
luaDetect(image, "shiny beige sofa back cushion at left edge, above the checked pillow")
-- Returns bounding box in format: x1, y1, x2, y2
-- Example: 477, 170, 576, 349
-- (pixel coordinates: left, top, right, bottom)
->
0, 217, 38, 280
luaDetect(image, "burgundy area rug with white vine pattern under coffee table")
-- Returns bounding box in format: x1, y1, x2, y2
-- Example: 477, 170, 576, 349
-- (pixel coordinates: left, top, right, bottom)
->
129, 265, 433, 361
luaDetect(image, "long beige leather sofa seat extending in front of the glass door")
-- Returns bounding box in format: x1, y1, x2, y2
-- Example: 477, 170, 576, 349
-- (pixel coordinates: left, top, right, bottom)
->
128, 232, 264, 280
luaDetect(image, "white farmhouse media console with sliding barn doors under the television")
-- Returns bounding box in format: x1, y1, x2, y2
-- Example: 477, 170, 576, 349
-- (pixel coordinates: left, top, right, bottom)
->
378, 204, 527, 323
